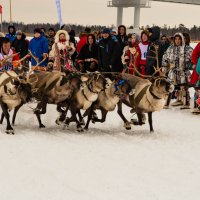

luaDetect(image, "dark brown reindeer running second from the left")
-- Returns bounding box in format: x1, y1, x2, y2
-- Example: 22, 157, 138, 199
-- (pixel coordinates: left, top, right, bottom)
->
33, 72, 82, 128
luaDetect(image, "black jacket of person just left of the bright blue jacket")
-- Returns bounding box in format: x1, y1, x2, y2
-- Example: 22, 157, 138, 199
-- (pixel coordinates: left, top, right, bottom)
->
12, 34, 28, 58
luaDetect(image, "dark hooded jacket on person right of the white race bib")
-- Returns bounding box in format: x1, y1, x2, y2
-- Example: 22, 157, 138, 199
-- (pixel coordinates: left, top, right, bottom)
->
146, 26, 164, 75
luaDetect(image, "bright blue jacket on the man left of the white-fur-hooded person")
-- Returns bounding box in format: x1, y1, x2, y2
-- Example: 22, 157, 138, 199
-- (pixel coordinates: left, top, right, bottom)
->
29, 36, 48, 66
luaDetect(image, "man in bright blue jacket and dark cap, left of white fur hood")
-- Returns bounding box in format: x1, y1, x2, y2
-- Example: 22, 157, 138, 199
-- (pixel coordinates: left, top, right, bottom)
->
29, 28, 48, 70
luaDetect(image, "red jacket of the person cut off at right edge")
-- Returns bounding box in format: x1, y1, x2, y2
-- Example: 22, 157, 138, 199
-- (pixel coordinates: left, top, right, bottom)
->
191, 43, 200, 85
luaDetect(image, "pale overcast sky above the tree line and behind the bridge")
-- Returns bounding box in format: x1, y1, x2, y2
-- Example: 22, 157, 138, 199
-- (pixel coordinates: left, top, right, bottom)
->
0, 0, 200, 27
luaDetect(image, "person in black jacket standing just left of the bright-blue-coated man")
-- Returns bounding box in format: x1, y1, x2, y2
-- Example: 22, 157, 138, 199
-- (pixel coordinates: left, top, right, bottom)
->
12, 30, 29, 71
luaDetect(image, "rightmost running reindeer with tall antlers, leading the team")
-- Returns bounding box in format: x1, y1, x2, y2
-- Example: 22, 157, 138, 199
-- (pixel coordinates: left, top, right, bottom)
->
119, 46, 174, 132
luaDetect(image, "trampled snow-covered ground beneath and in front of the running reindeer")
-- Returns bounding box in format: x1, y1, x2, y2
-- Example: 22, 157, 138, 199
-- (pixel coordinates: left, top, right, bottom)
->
0, 98, 200, 200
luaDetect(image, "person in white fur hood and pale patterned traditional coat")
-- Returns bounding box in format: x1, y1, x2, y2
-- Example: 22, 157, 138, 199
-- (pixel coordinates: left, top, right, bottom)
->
48, 30, 76, 71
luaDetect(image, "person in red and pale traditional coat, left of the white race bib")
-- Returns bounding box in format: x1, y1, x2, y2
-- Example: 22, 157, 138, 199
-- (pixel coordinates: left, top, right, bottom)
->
122, 33, 141, 75
